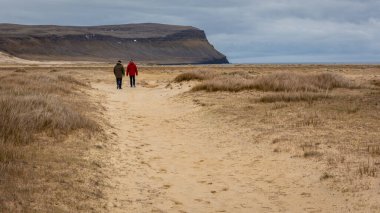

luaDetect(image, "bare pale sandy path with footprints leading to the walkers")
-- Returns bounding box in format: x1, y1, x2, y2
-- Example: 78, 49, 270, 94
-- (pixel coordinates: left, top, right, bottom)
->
94, 78, 346, 212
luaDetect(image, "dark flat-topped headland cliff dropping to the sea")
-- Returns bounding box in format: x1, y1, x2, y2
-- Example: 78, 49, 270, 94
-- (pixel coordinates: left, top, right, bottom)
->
0, 24, 228, 64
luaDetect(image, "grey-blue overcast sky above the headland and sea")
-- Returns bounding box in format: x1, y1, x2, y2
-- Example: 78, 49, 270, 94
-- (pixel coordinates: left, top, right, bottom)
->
0, 0, 380, 63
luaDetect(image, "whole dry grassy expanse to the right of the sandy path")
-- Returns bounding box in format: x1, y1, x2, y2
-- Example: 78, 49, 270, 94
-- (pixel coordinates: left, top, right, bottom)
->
174, 65, 380, 200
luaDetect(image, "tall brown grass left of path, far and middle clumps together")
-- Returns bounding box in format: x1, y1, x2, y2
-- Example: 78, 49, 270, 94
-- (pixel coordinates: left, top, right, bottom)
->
0, 75, 98, 144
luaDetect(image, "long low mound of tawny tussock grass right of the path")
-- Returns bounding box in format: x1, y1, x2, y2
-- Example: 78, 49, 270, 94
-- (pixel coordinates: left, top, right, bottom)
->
192, 73, 358, 92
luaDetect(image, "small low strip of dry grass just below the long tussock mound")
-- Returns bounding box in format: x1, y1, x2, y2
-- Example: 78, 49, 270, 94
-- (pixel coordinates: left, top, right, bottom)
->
259, 92, 331, 103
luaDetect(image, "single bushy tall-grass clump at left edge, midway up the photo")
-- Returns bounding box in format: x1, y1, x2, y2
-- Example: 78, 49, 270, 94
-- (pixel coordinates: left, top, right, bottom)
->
0, 94, 97, 144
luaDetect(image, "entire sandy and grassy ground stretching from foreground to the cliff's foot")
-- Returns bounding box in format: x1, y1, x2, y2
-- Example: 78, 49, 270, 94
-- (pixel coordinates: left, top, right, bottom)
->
0, 60, 380, 212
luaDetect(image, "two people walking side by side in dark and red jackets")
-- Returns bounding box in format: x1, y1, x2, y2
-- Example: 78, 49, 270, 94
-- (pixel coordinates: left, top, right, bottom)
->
113, 59, 139, 89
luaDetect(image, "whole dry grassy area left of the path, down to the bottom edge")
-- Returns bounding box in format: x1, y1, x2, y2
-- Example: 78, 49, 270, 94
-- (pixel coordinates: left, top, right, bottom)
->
0, 72, 101, 212
